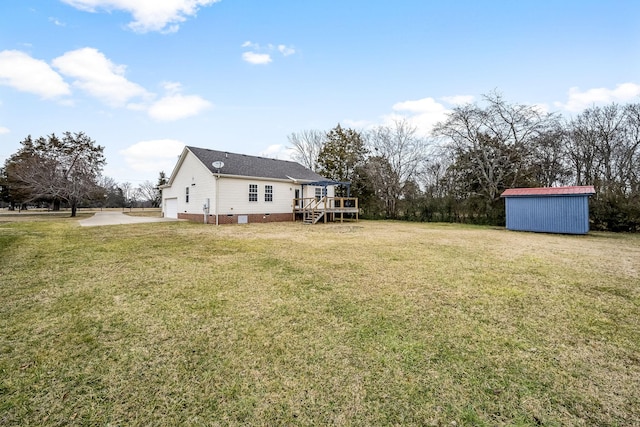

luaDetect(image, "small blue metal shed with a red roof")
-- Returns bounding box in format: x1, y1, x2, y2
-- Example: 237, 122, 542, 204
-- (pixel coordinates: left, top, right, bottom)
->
500, 185, 595, 234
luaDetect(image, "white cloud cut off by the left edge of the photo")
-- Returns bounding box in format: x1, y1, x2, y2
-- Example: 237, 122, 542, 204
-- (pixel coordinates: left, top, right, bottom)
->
0, 50, 71, 99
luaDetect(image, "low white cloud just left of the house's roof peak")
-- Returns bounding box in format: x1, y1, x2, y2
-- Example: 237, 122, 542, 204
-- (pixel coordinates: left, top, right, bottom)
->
119, 139, 185, 174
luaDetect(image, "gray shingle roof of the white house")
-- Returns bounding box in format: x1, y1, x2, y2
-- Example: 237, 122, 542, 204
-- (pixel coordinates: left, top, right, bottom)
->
187, 147, 326, 181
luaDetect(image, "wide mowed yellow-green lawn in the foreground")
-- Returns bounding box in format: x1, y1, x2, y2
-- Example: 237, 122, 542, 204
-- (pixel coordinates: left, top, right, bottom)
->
0, 217, 640, 426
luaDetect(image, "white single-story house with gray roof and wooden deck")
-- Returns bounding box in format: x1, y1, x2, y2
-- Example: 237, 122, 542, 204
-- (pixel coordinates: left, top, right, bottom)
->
161, 147, 357, 224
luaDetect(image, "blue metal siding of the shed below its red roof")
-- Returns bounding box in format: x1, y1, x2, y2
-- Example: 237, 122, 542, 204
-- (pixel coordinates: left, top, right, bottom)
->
505, 195, 589, 234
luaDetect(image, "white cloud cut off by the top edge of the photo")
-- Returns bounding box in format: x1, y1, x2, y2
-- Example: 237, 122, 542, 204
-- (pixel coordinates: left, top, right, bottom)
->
62, 0, 220, 33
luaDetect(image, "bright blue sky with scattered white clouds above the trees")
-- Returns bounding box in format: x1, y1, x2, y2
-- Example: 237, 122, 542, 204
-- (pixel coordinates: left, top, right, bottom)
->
0, 0, 640, 186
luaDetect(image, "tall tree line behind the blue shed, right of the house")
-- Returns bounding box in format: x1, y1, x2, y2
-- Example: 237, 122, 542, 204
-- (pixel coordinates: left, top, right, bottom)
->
288, 92, 640, 232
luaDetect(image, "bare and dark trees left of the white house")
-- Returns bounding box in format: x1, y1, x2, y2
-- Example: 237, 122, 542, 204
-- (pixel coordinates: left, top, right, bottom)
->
0, 132, 167, 216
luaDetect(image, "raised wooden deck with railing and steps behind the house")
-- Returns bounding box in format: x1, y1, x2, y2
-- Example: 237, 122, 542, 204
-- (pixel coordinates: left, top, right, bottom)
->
293, 197, 360, 224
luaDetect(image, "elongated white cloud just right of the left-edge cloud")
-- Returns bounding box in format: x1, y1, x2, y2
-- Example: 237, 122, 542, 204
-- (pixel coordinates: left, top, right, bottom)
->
53, 47, 150, 107
